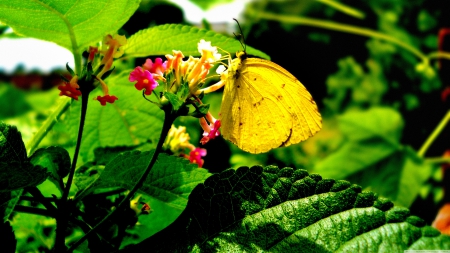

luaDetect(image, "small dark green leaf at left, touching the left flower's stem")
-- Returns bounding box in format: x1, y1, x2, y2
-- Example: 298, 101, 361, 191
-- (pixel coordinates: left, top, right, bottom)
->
30, 147, 70, 192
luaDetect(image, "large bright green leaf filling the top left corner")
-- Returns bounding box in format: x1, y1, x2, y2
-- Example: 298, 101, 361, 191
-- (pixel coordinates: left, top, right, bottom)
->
0, 0, 139, 52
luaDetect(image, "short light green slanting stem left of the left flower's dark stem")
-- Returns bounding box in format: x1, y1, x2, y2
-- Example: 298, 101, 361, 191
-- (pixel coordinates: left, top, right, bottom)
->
26, 97, 72, 155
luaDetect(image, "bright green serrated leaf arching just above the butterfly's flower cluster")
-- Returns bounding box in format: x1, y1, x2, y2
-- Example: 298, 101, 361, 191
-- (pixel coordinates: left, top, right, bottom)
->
123, 24, 270, 59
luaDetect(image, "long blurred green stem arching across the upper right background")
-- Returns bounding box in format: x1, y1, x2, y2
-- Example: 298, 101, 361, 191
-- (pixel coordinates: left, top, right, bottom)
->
254, 12, 428, 61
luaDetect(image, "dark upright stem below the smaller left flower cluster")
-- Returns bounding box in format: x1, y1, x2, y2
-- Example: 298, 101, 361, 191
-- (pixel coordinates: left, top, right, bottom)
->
55, 92, 89, 252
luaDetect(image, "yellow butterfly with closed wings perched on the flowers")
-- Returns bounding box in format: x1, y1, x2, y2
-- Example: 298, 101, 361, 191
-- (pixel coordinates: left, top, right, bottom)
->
220, 50, 322, 154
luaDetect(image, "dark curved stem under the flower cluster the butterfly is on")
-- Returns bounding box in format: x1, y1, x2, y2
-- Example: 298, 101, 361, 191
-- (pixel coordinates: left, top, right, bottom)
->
67, 110, 177, 252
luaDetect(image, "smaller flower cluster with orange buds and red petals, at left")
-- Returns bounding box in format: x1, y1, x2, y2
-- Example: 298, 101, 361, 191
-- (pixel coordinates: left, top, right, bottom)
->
58, 35, 127, 105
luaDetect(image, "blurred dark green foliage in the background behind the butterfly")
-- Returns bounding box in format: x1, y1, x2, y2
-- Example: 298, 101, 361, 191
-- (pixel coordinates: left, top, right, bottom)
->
0, 0, 450, 251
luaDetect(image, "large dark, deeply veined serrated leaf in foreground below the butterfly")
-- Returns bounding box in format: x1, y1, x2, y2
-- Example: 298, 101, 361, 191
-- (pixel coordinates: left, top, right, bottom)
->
121, 166, 450, 253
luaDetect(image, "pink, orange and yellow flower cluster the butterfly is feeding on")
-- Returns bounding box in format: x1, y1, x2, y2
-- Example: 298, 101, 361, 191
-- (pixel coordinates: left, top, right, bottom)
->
129, 40, 225, 167
